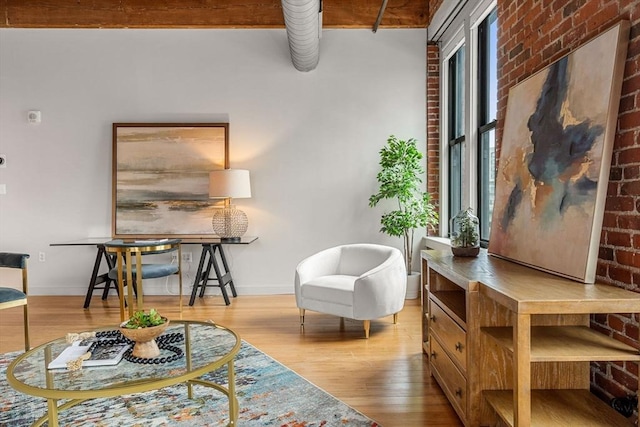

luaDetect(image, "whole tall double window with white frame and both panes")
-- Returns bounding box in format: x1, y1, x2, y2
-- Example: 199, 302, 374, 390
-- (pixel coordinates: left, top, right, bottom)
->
427, 0, 498, 247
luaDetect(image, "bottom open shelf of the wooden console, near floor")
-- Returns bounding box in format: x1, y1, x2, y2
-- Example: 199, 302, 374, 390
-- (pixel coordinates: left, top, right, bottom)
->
482, 390, 633, 427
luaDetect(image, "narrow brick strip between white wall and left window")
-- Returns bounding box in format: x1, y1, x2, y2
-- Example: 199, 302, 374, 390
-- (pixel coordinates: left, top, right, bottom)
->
427, 43, 440, 235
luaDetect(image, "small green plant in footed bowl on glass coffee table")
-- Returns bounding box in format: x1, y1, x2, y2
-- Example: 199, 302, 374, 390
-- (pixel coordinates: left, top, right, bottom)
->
120, 308, 169, 359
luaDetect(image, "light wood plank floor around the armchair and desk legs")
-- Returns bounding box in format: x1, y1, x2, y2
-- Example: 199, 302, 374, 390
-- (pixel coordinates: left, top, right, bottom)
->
0, 293, 462, 427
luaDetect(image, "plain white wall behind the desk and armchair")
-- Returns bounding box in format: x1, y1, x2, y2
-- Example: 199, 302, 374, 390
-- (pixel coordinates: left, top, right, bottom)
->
0, 29, 426, 295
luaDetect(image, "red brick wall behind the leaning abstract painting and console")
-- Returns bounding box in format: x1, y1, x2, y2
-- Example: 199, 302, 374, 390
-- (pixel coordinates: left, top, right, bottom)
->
496, 0, 640, 408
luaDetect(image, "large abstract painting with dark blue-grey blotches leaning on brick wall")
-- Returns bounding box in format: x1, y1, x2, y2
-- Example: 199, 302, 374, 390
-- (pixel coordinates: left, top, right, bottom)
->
489, 21, 629, 283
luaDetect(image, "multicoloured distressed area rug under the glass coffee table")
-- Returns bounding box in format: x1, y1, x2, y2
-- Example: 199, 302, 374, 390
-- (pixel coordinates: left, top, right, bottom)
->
0, 341, 379, 427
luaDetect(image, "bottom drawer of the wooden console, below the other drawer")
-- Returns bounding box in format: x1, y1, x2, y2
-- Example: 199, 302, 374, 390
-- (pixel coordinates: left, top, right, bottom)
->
429, 339, 467, 420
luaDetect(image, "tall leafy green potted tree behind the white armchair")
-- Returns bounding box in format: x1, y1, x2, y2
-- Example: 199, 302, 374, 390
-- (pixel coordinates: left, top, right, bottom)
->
369, 135, 438, 298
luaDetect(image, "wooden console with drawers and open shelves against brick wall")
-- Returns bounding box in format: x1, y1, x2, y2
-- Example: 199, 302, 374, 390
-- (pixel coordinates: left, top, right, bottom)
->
421, 251, 640, 427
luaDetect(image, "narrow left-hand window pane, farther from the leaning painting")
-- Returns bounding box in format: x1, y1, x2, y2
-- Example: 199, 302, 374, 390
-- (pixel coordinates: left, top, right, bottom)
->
448, 46, 465, 226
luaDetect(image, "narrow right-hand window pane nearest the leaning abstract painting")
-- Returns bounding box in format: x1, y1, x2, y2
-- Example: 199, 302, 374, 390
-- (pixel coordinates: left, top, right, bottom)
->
477, 9, 498, 246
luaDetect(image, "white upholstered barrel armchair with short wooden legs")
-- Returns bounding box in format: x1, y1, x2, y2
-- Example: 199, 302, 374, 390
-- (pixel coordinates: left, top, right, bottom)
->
295, 243, 407, 338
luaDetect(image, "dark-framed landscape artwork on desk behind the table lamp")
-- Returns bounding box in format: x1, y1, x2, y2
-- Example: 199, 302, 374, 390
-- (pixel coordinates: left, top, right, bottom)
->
111, 123, 229, 238
